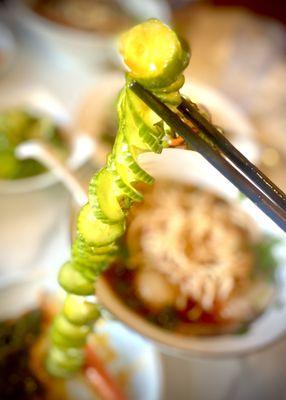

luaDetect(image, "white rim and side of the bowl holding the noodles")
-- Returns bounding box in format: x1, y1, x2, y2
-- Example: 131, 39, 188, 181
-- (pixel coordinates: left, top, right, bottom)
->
97, 149, 286, 357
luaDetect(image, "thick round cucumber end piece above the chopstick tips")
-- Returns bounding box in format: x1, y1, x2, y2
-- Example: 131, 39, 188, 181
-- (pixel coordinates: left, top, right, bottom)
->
120, 19, 189, 89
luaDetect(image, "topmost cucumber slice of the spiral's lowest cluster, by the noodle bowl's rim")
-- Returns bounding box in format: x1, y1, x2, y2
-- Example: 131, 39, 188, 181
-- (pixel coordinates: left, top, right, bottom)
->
63, 294, 100, 325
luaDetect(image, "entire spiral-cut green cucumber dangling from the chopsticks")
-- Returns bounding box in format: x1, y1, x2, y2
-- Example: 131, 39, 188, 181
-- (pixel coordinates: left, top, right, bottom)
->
46, 19, 189, 377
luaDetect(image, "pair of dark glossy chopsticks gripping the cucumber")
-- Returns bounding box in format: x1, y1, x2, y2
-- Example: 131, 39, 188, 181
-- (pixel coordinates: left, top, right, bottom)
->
129, 81, 286, 232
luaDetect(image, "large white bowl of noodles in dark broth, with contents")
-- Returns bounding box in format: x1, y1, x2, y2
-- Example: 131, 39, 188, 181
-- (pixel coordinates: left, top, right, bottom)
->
93, 149, 286, 357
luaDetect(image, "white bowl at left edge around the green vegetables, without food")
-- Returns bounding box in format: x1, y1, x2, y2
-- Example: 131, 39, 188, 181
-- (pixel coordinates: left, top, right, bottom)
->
0, 87, 93, 194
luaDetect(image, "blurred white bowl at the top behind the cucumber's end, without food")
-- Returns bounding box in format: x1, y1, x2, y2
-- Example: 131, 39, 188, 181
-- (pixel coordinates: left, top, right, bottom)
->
9, 0, 170, 66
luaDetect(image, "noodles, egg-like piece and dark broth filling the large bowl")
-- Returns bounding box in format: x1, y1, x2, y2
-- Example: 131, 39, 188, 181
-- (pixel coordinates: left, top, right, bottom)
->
105, 181, 277, 335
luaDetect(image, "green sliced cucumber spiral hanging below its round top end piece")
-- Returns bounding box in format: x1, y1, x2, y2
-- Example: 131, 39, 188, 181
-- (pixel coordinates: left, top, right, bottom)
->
46, 17, 189, 379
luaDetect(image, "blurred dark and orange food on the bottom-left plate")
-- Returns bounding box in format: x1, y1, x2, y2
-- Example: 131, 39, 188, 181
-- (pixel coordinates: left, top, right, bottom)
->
0, 296, 128, 400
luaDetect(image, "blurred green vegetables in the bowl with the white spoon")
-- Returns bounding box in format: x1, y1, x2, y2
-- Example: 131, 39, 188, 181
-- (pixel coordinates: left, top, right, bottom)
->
0, 108, 68, 179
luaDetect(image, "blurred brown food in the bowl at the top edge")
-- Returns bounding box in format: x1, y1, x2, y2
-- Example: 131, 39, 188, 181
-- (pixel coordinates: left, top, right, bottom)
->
32, 0, 132, 34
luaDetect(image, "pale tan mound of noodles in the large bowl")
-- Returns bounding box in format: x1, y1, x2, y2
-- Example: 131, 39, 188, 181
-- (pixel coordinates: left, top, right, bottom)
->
127, 182, 255, 312
